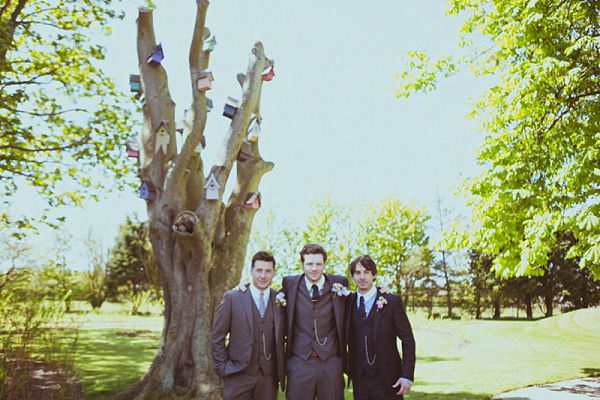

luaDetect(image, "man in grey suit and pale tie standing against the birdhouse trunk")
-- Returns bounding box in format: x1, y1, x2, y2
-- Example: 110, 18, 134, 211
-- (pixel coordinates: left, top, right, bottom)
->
210, 251, 285, 400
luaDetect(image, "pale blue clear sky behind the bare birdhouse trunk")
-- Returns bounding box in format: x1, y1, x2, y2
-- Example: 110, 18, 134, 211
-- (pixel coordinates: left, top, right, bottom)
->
9, 0, 485, 269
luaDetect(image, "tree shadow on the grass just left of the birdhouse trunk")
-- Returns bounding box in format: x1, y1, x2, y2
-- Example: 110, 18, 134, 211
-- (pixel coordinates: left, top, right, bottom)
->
75, 329, 160, 400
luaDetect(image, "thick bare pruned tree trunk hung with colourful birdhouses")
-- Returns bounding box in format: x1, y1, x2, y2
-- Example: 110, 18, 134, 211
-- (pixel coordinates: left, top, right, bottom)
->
121, 4, 273, 400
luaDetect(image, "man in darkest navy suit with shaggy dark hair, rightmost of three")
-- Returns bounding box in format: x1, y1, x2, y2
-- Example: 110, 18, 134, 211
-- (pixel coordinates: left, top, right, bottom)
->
346, 255, 415, 400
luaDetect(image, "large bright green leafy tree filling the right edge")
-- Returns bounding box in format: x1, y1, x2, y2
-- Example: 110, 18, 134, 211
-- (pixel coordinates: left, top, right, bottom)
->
396, 0, 600, 278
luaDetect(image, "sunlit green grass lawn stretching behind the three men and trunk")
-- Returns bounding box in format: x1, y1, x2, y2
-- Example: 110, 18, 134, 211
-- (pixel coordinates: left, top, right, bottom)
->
76, 308, 600, 400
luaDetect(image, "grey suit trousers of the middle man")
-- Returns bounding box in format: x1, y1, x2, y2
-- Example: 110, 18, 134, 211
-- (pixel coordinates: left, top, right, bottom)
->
285, 355, 344, 400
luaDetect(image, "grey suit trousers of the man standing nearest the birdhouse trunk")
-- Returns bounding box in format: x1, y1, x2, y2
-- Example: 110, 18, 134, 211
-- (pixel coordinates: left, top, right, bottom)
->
223, 369, 277, 400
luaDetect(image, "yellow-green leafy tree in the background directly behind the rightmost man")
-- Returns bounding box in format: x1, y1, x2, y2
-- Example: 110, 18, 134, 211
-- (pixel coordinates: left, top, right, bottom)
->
358, 196, 433, 306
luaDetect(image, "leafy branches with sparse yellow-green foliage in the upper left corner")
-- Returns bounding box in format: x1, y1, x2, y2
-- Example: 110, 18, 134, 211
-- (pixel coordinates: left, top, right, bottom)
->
0, 0, 130, 216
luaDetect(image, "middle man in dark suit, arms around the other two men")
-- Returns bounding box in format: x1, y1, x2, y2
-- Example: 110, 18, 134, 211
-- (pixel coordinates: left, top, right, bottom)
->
281, 244, 349, 400
